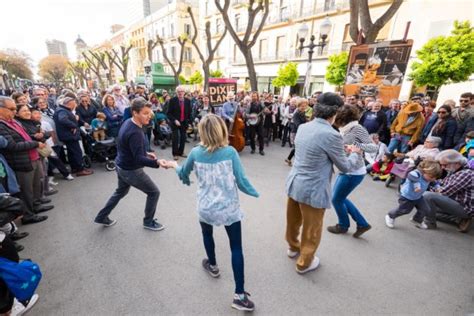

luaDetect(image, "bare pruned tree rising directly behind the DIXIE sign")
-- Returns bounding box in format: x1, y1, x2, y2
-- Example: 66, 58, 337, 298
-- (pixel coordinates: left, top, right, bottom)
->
188, 7, 227, 91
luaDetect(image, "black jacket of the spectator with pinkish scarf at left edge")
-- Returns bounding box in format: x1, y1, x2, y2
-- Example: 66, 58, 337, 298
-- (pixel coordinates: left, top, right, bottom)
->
0, 121, 39, 172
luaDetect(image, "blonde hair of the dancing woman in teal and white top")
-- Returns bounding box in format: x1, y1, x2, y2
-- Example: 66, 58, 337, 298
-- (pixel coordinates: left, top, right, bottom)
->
198, 114, 229, 153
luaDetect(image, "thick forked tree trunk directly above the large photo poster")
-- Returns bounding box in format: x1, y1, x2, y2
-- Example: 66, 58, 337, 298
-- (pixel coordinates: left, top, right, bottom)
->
349, 0, 403, 43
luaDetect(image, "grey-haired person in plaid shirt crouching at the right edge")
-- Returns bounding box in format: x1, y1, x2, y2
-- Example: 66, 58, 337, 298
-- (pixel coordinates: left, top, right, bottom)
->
423, 149, 474, 233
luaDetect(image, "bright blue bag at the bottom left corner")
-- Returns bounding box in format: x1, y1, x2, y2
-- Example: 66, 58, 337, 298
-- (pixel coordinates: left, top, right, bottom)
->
0, 257, 42, 301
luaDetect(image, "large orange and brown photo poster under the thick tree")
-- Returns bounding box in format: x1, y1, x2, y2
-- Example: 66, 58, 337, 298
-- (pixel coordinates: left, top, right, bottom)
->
344, 40, 413, 105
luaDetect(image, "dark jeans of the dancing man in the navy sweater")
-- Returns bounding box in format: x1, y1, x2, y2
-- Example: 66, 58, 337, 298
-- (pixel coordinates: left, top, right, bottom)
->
95, 166, 160, 224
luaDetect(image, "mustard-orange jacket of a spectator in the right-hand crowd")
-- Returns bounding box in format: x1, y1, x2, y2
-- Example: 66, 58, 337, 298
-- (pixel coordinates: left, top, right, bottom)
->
390, 102, 425, 143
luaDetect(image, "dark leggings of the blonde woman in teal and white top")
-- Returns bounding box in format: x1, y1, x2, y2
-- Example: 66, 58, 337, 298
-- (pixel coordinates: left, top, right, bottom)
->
200, 221, 244, 294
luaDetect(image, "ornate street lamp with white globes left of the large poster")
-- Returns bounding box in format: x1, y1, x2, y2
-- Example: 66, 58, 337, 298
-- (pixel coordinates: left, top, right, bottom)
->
298, 16, 332, 96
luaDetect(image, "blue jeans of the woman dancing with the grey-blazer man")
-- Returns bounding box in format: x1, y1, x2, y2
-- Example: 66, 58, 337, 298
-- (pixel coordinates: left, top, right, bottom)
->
332, 173, 369, 229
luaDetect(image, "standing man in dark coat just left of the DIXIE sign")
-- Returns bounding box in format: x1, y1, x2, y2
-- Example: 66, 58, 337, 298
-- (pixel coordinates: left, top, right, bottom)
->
166, 86, 192, 160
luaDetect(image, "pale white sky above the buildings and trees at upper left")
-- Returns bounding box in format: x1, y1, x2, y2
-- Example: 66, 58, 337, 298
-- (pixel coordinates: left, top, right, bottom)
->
0, 0, 143, 72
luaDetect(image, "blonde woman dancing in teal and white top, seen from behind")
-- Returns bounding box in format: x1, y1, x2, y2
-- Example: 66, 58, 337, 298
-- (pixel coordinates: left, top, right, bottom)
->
167, 114, 259, 311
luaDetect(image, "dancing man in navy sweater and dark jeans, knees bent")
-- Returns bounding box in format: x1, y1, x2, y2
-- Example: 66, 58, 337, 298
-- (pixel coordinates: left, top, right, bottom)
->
95, 97, 164, 231
